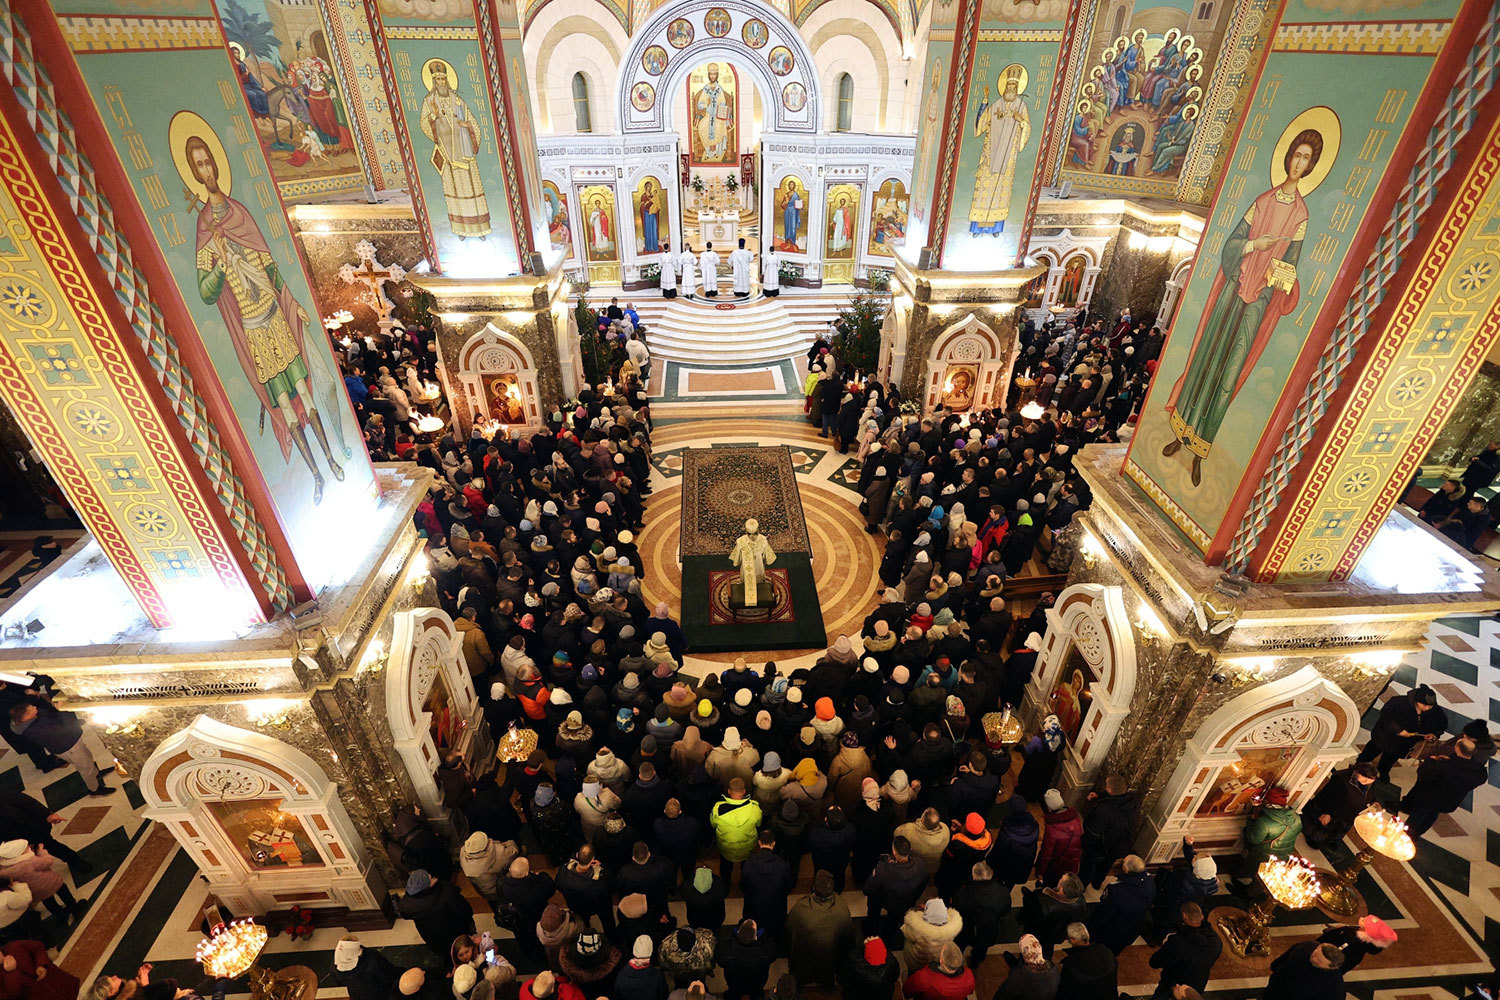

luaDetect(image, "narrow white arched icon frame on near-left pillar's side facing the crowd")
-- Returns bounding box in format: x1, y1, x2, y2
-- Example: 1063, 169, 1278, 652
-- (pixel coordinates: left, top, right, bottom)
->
386, 607, 495, 837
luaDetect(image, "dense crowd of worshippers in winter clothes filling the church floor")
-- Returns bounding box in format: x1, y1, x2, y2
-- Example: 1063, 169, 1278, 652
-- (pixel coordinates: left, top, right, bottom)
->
0, 303, 1494, 1000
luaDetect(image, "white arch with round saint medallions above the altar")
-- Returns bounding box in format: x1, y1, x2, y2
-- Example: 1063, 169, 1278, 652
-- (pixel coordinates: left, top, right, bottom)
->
618, 0, 819, 133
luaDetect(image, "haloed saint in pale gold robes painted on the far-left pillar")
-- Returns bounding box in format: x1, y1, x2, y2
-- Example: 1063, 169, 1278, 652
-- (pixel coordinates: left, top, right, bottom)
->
422, 58, 491, 240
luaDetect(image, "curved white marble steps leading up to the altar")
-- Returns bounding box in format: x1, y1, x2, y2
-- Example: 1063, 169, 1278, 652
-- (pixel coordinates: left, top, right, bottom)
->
633, 292, 849, 364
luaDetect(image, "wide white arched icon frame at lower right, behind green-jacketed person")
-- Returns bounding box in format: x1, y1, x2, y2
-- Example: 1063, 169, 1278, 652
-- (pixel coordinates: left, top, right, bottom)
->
1140, 664, 1359, 864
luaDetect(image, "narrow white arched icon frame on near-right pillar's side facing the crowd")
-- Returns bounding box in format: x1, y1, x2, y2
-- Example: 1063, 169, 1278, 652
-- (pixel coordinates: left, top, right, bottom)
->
1026, 583, 1136, 801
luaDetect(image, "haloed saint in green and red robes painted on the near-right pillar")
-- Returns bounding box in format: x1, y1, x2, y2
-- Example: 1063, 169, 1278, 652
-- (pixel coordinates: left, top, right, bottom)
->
1161, 108, 1338, 486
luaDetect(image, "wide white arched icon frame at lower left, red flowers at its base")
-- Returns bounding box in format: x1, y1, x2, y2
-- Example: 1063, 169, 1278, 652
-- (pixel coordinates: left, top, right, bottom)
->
140, 715, 386, 913
